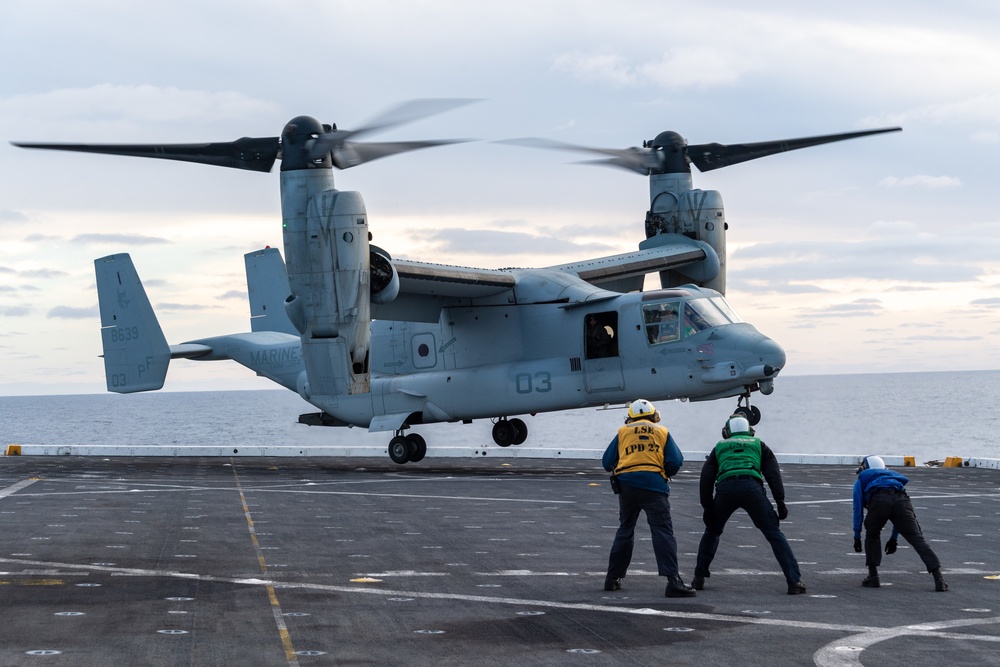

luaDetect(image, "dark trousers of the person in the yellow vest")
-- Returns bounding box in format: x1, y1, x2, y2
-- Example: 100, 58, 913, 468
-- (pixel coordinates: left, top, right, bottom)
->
608, 484, 678, 579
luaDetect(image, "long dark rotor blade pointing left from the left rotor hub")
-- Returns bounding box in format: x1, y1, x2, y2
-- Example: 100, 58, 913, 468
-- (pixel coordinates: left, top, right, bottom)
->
11, 137, 281, 171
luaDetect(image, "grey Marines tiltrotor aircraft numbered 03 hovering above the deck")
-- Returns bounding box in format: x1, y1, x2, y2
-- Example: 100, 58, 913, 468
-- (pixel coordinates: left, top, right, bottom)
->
16, 100, 899, 463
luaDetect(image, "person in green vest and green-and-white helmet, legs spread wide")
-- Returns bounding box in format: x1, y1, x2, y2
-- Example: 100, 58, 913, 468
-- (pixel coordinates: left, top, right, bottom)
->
691, 414, 806, 595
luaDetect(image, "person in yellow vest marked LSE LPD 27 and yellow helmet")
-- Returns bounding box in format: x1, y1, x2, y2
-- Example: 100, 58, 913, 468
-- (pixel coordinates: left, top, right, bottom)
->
601, 399, 695, 598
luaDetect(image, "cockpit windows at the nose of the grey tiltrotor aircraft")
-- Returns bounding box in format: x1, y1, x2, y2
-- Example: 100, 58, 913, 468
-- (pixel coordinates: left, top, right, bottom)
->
642, 289, 743, 345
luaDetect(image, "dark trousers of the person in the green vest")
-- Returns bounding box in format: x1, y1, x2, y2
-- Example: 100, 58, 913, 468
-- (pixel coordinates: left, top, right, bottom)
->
694, 478, 801, 584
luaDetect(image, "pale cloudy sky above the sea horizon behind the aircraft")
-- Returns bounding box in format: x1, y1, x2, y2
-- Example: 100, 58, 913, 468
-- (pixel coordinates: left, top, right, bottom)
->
0, 0, 1000, 395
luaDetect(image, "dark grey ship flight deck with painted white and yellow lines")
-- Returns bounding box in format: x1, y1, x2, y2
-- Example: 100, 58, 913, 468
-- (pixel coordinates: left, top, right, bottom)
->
0, 456, 1000, 667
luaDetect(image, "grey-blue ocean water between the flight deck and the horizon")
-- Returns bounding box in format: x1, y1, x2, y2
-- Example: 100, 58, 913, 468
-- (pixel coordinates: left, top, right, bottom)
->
0, 371, 1000, 463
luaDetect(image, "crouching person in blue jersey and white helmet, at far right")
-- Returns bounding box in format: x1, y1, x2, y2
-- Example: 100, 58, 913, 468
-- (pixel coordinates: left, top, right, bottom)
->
853, 456, 948, 593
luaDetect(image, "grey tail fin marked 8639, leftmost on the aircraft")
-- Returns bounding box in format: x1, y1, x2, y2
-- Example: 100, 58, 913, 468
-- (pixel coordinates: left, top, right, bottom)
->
94, 253, 170, 394
